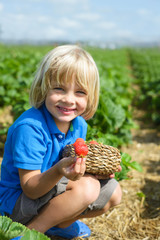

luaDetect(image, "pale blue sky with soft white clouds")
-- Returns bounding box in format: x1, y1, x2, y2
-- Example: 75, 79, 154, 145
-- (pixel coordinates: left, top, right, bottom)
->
0, 0, 160, 45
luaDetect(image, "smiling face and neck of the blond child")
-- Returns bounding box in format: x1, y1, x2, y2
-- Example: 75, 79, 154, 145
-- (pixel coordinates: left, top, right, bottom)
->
45, 76, 88, 133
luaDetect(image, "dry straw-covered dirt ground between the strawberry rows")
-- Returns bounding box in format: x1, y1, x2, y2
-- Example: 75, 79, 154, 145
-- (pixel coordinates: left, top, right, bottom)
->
0, 109, 160, 240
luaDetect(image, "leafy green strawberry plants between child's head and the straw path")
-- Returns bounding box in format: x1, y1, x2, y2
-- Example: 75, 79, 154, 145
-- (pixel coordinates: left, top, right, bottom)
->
87, 49, 135, 146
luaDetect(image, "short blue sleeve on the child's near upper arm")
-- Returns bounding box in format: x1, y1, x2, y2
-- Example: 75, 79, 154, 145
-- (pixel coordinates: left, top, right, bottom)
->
11, 124, 46, 170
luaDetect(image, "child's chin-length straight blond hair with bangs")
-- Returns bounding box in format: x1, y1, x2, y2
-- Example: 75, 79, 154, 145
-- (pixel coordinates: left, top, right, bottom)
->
30, 45, 99, 120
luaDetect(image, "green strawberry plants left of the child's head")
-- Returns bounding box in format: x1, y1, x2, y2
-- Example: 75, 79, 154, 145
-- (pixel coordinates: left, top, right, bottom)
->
0, 45, 49, 119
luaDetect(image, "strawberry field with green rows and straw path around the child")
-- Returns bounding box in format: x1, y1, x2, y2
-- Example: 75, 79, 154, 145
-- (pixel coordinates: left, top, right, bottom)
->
0, 46, 160, 240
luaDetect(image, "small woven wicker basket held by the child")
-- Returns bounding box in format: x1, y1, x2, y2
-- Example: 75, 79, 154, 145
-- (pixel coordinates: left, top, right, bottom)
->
62, 143, 121, 175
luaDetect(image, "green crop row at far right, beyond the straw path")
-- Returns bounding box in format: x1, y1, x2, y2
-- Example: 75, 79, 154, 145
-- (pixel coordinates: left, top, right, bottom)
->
129, 48, 160, 124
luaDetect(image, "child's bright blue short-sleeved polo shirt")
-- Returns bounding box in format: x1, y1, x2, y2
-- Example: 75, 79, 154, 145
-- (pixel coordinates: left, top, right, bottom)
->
0, 105, 87, 214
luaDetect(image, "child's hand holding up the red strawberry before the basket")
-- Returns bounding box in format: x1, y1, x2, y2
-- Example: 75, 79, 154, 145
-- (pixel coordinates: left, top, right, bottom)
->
57, 157, 86, 181
